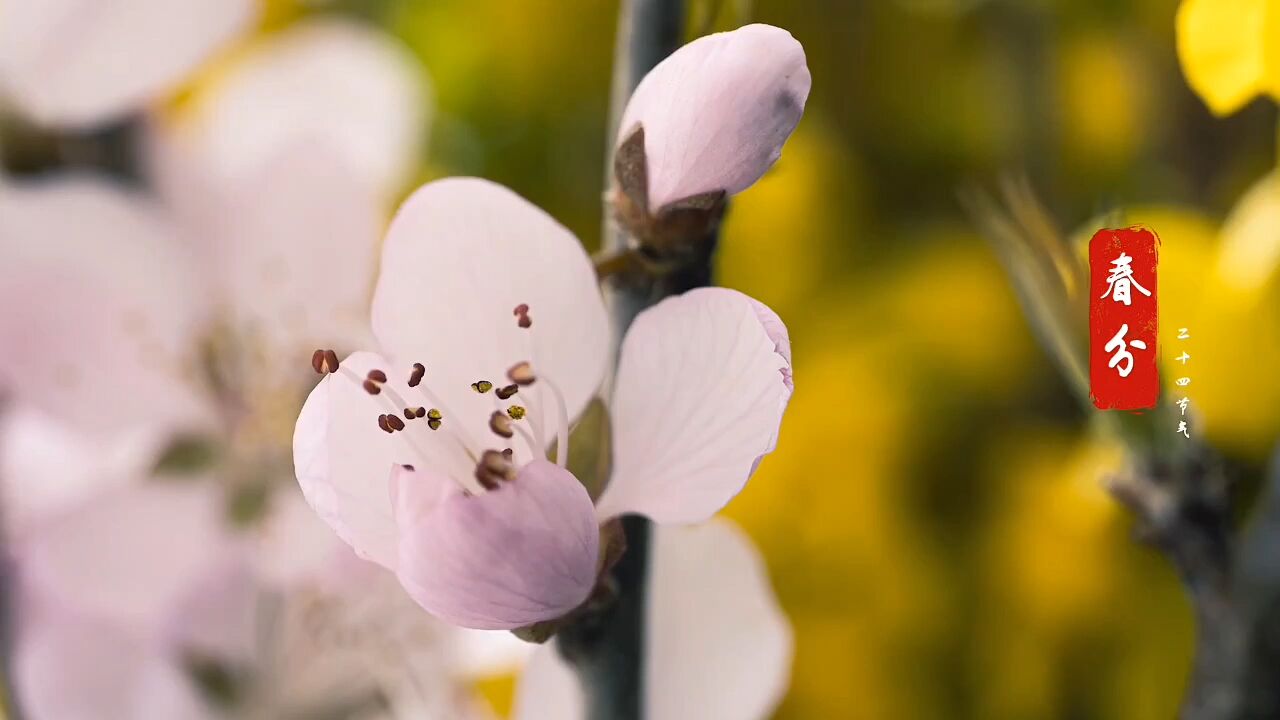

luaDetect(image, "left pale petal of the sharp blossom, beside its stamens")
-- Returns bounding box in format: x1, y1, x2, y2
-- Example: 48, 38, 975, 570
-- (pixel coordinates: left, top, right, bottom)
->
293, 352, 475, 570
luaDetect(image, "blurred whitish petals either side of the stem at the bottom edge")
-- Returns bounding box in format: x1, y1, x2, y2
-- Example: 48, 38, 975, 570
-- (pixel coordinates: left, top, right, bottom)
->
513, 519, 794, 720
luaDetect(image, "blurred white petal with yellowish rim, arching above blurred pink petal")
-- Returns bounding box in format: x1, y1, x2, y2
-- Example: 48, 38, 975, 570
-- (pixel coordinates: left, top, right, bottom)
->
183, 19, 430, 191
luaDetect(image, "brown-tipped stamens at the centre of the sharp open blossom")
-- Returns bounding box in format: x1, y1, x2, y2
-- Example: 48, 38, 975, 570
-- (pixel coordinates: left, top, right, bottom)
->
311, 304, 568, 493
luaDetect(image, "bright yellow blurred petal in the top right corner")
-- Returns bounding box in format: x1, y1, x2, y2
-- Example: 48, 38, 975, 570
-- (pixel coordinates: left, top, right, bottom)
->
1178, 0, 1280, 115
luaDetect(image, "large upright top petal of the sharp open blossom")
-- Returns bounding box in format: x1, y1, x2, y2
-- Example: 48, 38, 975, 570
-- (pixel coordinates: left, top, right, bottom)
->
372, 178, 609, 443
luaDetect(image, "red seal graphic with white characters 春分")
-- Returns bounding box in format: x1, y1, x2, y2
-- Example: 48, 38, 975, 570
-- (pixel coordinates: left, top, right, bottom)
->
1089, 225, 1160, 410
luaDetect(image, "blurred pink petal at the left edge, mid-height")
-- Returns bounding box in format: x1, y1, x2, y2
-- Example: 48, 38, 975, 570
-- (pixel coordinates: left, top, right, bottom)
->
0, 177, 209, 433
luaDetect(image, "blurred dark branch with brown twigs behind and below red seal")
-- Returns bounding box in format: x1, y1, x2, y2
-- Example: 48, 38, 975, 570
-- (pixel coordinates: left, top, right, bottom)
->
961, 179, 1280, 720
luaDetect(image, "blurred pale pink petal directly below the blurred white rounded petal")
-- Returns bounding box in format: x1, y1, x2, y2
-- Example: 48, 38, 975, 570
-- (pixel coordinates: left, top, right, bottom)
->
197, 143, 385, 376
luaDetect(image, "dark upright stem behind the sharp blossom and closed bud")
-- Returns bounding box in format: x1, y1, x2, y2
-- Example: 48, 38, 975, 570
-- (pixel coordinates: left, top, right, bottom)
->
556, 0, 686, 720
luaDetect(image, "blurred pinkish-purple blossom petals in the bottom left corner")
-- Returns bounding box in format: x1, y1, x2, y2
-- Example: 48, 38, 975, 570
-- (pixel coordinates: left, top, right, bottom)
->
12, 482, 252, 720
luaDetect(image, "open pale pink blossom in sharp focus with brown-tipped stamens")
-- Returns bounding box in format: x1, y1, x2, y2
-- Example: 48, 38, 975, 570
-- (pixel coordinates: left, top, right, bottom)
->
294, 178, 791, 629
